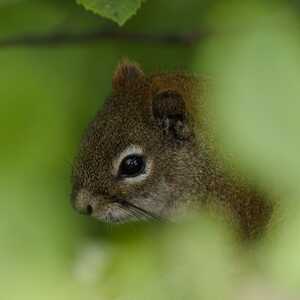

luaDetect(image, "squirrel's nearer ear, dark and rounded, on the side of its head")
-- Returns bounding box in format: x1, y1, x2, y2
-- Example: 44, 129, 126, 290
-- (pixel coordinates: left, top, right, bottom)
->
152, 90, 191, 141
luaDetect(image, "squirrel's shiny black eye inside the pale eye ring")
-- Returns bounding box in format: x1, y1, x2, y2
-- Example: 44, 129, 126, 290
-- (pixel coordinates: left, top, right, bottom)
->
119, 154, 146, 177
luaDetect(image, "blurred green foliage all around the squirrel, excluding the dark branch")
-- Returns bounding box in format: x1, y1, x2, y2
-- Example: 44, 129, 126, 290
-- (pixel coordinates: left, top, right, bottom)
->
0, 0, 300, 300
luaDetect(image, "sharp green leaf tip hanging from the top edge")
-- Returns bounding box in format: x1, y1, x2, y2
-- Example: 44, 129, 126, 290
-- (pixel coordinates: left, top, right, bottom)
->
77, 0, 144, 26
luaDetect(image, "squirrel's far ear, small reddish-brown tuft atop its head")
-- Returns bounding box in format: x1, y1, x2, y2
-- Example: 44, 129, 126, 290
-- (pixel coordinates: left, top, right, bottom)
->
112, 59, 145, 90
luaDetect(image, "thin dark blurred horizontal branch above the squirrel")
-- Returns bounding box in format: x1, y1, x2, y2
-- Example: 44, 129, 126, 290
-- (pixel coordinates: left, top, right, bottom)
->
0, 31, 209, 48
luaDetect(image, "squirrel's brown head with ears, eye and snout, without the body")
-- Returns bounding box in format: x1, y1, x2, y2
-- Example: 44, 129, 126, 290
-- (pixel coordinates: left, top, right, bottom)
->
72, 61, 203, 222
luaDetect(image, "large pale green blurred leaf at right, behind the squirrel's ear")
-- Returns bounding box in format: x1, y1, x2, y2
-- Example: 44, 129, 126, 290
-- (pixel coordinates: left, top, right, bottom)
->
198, 8, 300, 197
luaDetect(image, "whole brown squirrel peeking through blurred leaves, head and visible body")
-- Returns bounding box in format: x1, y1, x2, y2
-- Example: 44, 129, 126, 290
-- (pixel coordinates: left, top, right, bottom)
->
71, 60, 273, 239
